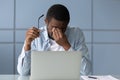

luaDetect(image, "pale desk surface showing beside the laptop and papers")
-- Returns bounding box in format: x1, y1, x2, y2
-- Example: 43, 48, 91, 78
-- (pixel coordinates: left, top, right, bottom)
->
0, 75, 120, 80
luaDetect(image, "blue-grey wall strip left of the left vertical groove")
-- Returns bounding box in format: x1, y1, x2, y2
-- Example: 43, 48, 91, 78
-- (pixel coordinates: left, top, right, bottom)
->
0, 0, 14, 74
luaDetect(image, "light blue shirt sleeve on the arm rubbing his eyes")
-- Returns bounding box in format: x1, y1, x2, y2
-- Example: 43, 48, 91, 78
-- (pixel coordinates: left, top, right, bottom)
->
68, 28, 92, 75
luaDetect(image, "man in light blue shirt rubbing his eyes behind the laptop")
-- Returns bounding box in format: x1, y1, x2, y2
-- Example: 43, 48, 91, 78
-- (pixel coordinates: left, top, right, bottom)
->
17, 4, 91, 75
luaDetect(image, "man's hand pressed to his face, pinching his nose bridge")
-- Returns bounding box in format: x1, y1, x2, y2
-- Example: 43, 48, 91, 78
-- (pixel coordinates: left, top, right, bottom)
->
52, 28, 71, 50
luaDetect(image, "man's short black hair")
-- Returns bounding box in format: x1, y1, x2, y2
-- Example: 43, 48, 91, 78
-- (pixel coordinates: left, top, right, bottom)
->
46, 4, 70, 23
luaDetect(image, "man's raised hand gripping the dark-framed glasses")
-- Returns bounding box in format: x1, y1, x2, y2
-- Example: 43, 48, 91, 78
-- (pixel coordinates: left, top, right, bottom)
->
24, 27, 40, 51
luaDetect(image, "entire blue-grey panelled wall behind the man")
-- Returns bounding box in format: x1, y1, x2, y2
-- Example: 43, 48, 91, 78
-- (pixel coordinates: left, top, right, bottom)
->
0, 0, 120, 75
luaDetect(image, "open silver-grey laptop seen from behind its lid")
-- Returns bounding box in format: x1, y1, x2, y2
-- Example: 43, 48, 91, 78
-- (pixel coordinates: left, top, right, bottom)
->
30, 51, 82, 80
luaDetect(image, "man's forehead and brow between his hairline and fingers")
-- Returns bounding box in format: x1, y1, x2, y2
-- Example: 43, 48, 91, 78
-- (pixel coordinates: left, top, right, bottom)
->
49, 18, 67, 28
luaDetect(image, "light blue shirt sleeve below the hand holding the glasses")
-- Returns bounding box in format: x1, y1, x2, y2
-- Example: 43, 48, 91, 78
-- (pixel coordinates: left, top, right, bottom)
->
17, 42, 31, 75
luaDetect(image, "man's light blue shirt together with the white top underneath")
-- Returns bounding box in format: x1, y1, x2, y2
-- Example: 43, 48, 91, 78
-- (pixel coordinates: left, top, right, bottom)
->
17, 26, 91, 75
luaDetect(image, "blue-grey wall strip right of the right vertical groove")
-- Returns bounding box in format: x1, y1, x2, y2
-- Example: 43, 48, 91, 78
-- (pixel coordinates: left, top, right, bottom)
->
93, 0, 120, 75
